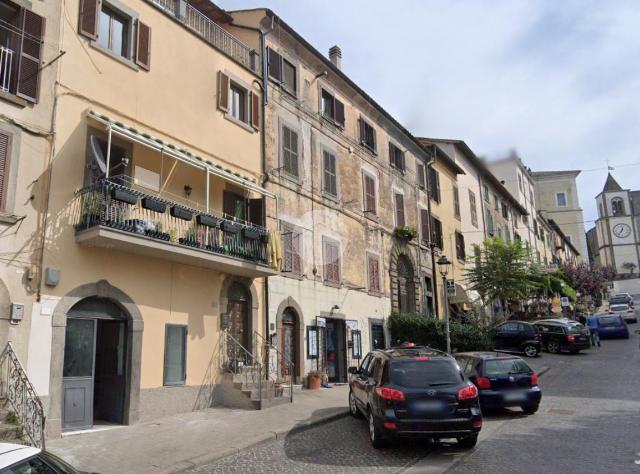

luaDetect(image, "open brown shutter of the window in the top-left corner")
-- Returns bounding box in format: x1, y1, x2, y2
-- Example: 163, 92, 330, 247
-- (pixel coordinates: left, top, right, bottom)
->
16, 9, 44, 102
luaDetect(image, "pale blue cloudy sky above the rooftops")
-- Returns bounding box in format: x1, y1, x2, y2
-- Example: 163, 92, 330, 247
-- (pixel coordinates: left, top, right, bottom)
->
216, 0, 640, 227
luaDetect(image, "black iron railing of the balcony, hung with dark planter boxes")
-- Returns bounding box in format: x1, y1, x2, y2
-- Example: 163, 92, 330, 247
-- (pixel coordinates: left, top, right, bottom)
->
73, 179, 268, 265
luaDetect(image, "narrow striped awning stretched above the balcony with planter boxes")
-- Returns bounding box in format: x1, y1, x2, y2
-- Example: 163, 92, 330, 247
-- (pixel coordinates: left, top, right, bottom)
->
87, 110, 275, 198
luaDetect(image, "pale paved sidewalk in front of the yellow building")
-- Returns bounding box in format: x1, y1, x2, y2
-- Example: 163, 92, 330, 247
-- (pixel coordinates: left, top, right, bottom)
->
47, 386, 349, 474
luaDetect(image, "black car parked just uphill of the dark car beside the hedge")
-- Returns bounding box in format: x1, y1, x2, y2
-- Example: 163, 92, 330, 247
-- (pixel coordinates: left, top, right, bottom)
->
534, 318, 591, 354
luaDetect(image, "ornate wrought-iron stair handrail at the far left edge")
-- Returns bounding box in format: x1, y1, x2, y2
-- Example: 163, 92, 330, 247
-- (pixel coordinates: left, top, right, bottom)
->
0, 342, 46, 449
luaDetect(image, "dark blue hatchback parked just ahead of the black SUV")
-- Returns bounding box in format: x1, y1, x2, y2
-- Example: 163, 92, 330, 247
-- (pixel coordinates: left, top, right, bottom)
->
455, 352, 542, 415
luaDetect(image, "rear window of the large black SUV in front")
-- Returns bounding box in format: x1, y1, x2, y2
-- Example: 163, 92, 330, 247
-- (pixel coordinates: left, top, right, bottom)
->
389, 359, 464, 388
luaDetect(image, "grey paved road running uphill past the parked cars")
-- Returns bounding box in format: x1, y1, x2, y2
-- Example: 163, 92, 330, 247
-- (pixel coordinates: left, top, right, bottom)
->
193, 324, 640, 474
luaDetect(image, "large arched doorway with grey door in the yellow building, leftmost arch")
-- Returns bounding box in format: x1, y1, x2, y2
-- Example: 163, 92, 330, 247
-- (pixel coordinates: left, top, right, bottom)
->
62, 296, 131, 430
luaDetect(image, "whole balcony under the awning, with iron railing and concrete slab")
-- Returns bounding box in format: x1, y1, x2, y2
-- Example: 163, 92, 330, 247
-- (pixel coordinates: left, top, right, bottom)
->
72, 178, 277, 277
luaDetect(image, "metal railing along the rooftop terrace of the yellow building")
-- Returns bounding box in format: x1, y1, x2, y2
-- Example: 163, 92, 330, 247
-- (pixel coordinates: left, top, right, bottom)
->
150, 0, 261, 75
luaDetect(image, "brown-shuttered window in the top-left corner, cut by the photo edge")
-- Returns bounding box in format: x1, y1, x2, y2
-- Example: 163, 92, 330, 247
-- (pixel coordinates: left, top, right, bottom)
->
0, 1, 45, 102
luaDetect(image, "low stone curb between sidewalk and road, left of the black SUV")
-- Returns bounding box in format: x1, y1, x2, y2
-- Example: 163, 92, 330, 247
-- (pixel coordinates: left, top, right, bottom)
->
170, 408, 349, 474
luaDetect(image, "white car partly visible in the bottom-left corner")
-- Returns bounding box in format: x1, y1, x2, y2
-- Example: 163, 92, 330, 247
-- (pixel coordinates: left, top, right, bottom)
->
0, 443, 80, 474
